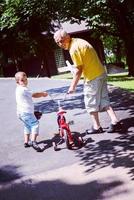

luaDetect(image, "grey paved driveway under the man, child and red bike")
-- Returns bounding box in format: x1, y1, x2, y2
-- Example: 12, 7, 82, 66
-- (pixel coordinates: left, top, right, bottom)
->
0, 78, 134, 200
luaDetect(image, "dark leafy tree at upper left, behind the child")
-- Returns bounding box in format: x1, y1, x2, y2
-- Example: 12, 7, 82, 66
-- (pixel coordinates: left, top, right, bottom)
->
0, 0, 60, 75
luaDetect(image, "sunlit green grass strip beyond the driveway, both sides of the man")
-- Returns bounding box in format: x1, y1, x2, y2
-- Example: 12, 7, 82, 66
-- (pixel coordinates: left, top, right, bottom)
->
52, 73, 134, 92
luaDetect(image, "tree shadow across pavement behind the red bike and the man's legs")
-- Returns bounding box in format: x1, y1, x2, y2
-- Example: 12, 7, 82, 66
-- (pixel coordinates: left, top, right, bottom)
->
35, 84, 134, 115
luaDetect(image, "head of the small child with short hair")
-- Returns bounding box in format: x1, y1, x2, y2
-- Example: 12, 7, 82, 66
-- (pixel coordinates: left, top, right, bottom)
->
15, 72, 28, 86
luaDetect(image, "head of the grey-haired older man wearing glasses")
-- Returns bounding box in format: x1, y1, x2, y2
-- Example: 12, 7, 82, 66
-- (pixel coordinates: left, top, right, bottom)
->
54, 29, 71, 50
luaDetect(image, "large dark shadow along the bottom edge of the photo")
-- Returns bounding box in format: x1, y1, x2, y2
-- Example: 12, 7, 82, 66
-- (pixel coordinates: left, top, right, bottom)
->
0, 174, 123, 200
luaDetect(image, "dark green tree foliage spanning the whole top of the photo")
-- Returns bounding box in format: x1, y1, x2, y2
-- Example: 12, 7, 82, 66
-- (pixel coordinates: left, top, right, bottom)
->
0, 0, 134, 74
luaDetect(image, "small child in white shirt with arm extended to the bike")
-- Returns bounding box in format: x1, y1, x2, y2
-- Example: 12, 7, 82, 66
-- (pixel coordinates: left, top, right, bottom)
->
15, 71, 48, 151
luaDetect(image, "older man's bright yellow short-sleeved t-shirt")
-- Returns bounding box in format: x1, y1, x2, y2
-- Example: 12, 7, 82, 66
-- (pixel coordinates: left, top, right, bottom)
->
69, 38, 105, 81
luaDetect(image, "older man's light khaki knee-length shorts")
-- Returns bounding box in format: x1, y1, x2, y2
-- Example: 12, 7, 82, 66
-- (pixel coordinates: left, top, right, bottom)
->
84, 74, 110, 113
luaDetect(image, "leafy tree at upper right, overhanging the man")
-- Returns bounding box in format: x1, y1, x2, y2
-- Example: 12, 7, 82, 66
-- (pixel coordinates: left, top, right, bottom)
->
55, 0, 134, 76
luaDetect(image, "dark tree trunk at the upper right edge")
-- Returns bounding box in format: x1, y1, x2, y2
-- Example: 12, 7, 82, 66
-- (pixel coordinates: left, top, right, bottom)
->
107, 0, 134, 76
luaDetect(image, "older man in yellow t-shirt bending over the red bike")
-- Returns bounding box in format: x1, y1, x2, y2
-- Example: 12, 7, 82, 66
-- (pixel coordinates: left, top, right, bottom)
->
54, 29, 120, 133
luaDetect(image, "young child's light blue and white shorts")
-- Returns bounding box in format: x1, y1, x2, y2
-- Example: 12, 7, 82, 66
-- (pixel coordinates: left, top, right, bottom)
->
18, 113, 39, 134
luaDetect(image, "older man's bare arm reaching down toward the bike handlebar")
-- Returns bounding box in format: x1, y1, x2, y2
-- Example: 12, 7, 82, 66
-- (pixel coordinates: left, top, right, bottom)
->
68, 66, 82, 93
